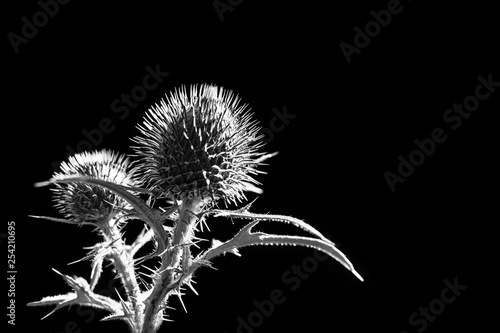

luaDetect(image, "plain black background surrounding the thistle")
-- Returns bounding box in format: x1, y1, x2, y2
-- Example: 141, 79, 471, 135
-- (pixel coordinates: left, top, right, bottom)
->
1, 1, 500, 333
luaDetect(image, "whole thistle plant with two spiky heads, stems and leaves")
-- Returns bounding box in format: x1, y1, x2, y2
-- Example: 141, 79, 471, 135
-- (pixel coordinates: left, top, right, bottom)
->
28, 85, 363, 333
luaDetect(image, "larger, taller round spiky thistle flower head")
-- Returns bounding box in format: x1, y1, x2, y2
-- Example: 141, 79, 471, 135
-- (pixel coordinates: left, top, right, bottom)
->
133, 84, 262, 203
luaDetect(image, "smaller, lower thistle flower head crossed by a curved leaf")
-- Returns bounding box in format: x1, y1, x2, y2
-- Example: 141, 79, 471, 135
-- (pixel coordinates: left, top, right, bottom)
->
53, 150, 140, 223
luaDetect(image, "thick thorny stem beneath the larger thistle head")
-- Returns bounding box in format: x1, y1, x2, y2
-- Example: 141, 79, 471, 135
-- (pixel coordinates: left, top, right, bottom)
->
142, 197, 203, 333
